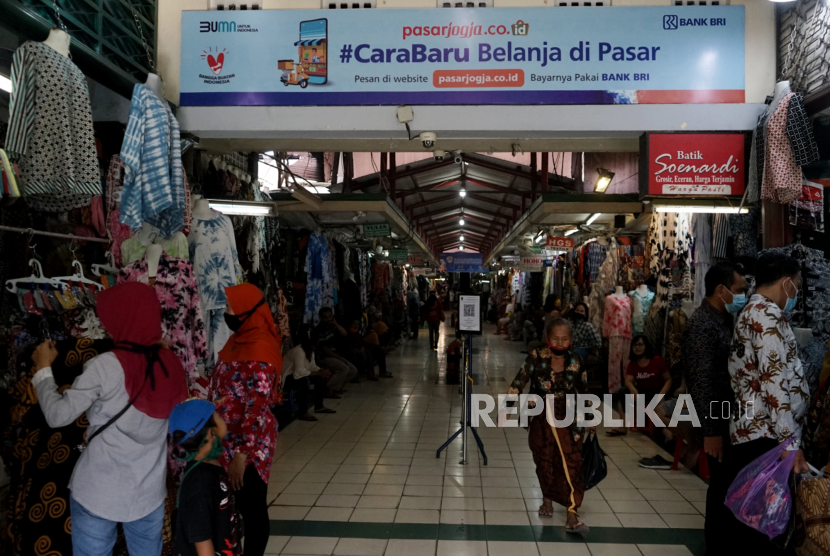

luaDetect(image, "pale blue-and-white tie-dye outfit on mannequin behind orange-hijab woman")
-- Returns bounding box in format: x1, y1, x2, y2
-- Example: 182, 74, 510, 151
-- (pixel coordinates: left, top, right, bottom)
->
187, 213, 243, 369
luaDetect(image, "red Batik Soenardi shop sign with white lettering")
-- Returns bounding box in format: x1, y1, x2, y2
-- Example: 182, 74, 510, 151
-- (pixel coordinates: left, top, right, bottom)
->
640, 133, 749, 197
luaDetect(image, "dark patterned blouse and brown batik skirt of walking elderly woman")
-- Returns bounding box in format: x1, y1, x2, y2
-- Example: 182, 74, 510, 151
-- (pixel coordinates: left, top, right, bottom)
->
508, 348, 588, 513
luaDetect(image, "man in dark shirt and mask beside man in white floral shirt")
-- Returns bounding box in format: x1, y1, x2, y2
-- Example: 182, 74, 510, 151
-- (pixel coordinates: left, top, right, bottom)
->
681, 262, 746, 554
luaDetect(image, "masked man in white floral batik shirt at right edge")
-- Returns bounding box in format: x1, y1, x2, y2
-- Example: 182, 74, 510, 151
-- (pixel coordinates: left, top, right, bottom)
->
720, 255, 810, 556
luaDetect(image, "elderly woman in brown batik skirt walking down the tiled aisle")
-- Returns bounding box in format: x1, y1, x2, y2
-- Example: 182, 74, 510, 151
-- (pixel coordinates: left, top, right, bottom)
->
508, 319, 596, 535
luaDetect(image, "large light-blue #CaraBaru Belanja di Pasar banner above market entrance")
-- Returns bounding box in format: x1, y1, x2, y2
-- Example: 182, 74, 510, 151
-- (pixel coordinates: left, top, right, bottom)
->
180, 6, 745, 106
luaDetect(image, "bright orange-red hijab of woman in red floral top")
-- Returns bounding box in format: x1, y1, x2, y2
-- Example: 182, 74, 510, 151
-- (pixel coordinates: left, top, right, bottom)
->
219, 284, 282, 381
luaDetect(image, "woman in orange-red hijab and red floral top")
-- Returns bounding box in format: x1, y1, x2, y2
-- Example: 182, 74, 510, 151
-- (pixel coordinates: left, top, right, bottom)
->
208, 284, 282, 556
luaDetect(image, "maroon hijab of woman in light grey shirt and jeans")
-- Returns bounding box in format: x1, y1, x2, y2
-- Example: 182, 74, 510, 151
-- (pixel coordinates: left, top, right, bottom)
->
98, 282, 187, 419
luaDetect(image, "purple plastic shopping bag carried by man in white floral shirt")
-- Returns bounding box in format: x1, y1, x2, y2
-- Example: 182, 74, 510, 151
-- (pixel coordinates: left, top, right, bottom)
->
725, 439, 795, 539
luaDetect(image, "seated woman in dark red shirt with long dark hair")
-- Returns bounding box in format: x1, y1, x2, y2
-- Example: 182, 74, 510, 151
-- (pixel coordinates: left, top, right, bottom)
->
607, 335, 671, 436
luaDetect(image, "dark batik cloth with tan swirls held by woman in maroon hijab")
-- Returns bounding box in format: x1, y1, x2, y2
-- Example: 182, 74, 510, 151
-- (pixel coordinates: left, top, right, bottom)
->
6, 340, 112, 556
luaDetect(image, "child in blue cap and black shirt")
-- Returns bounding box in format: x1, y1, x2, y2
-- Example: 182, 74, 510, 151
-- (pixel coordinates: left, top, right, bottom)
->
169, 399, 240, 556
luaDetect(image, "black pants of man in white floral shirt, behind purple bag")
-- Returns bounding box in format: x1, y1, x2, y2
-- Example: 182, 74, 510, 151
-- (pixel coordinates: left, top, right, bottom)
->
720, 438, 793, 556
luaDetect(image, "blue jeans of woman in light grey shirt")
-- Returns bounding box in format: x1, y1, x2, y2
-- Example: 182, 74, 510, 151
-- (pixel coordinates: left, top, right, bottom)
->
69, 496, 164, 556
